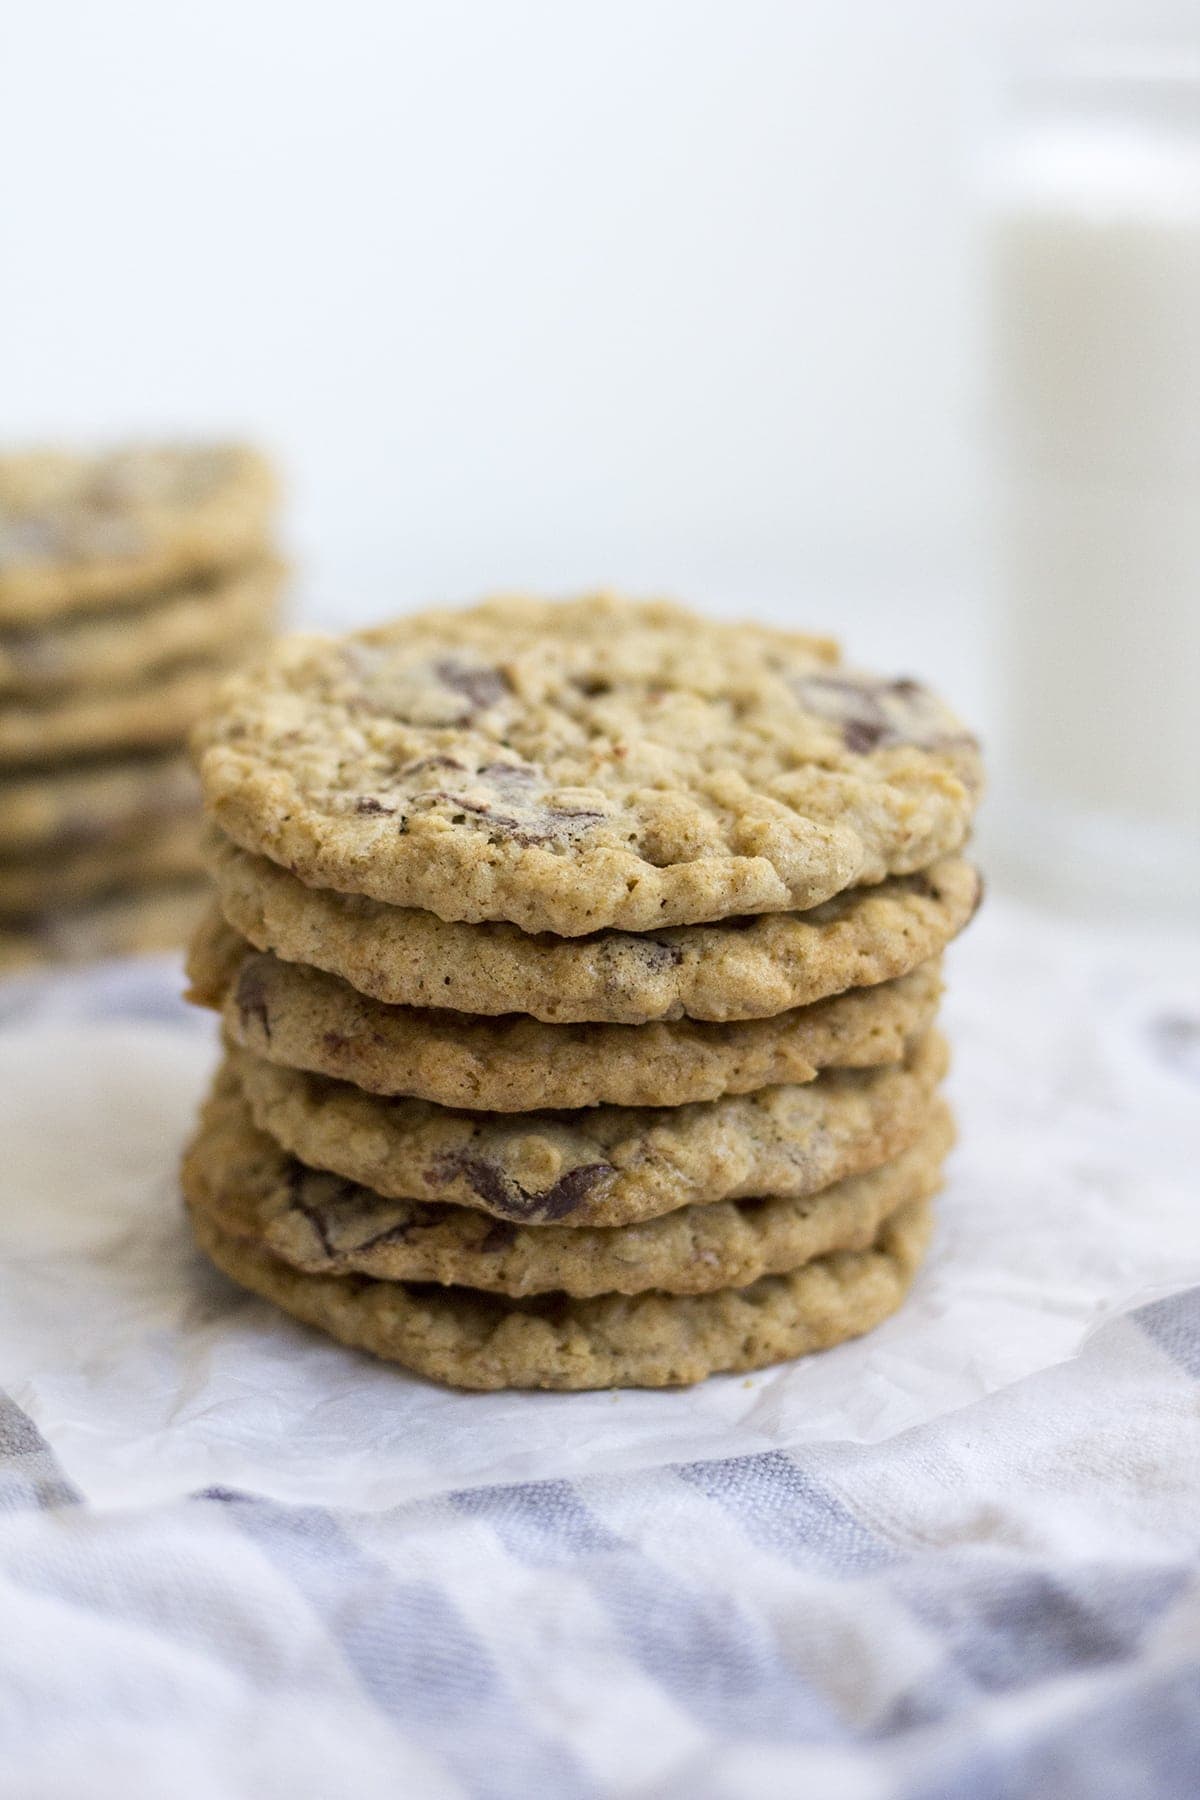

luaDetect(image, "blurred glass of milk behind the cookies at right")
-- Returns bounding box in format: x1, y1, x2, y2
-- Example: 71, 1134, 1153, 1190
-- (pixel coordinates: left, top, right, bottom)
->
986, 56, 1200, 925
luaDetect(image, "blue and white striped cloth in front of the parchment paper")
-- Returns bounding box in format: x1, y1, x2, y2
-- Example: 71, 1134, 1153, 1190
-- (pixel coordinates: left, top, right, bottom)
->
0, 1289, 1200, 1800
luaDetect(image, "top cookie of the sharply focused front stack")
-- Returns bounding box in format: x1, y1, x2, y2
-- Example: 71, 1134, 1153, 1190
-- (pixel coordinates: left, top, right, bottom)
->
196, 594, 981, 938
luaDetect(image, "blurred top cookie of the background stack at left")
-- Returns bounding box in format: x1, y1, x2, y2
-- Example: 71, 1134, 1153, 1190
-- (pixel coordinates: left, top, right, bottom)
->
0, 445, 275, 625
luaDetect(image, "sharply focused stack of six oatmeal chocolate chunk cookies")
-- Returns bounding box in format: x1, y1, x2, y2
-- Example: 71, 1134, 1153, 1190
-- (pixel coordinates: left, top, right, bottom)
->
184, 596, 981, 1388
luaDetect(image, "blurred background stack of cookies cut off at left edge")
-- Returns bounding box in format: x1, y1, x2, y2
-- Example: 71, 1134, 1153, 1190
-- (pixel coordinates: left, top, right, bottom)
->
0, 446, 281, 967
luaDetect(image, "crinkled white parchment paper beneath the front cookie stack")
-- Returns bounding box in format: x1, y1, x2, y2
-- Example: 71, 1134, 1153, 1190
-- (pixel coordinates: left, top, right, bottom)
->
0, 900, 1200, 1508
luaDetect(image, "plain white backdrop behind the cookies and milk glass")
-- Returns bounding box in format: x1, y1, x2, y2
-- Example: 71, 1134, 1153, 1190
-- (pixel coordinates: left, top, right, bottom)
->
0, 0, 1195, 730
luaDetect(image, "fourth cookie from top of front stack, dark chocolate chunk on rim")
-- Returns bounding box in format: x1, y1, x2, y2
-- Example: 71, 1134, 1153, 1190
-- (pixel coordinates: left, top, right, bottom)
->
228, 1031, 946, 1228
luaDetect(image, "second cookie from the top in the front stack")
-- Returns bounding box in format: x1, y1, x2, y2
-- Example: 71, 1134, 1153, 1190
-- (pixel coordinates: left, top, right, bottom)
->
205, 832, 981, 1024
